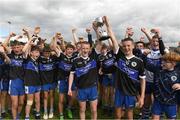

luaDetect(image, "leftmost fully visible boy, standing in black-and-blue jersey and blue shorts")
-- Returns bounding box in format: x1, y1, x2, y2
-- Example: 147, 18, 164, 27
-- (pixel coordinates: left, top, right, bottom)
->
8, 41, 25, 119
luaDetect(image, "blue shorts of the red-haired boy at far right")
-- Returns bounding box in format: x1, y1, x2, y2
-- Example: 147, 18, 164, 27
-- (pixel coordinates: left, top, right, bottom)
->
152, 100, 177, 119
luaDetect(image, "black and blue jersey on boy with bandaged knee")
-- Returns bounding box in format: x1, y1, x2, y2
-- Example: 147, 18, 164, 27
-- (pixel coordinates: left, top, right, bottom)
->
24, 57, 41, 86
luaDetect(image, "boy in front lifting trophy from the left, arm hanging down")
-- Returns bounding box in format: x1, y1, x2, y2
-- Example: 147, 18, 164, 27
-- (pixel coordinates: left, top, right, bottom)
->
68, 41, 98, 119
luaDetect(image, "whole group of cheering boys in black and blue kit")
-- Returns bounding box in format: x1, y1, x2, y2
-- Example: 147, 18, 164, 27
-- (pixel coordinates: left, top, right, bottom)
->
0, 16, 180, 120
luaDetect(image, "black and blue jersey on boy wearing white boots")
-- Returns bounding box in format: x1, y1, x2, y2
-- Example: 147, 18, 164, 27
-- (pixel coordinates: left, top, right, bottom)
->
39, 56, 56, 84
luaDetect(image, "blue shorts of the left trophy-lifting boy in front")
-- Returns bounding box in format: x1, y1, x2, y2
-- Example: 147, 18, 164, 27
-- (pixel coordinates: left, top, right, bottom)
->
77, 86, 98, 102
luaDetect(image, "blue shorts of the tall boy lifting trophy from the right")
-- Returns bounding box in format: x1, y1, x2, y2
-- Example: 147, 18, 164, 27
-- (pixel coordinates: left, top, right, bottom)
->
114, 89, 136, 108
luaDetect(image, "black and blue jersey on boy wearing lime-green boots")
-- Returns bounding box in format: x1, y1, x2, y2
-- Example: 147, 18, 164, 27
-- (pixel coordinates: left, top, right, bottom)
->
57, 53, 76, 80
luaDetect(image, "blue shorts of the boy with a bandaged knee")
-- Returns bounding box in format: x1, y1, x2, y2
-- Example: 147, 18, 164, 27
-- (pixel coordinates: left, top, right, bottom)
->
25, 86, 41, 94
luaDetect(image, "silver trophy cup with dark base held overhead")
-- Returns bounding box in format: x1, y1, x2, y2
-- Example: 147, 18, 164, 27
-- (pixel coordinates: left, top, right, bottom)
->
95, 17, 110, 41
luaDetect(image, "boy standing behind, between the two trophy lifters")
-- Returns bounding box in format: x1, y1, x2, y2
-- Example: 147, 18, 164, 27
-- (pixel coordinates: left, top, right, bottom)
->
98, 44, 115, 113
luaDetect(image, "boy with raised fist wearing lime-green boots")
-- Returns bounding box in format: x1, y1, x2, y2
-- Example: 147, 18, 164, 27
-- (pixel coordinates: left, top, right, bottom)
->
52, 38, 76, 120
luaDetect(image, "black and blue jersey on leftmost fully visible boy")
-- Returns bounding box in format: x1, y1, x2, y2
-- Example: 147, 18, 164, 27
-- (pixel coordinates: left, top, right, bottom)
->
8, 52, 24, 80
